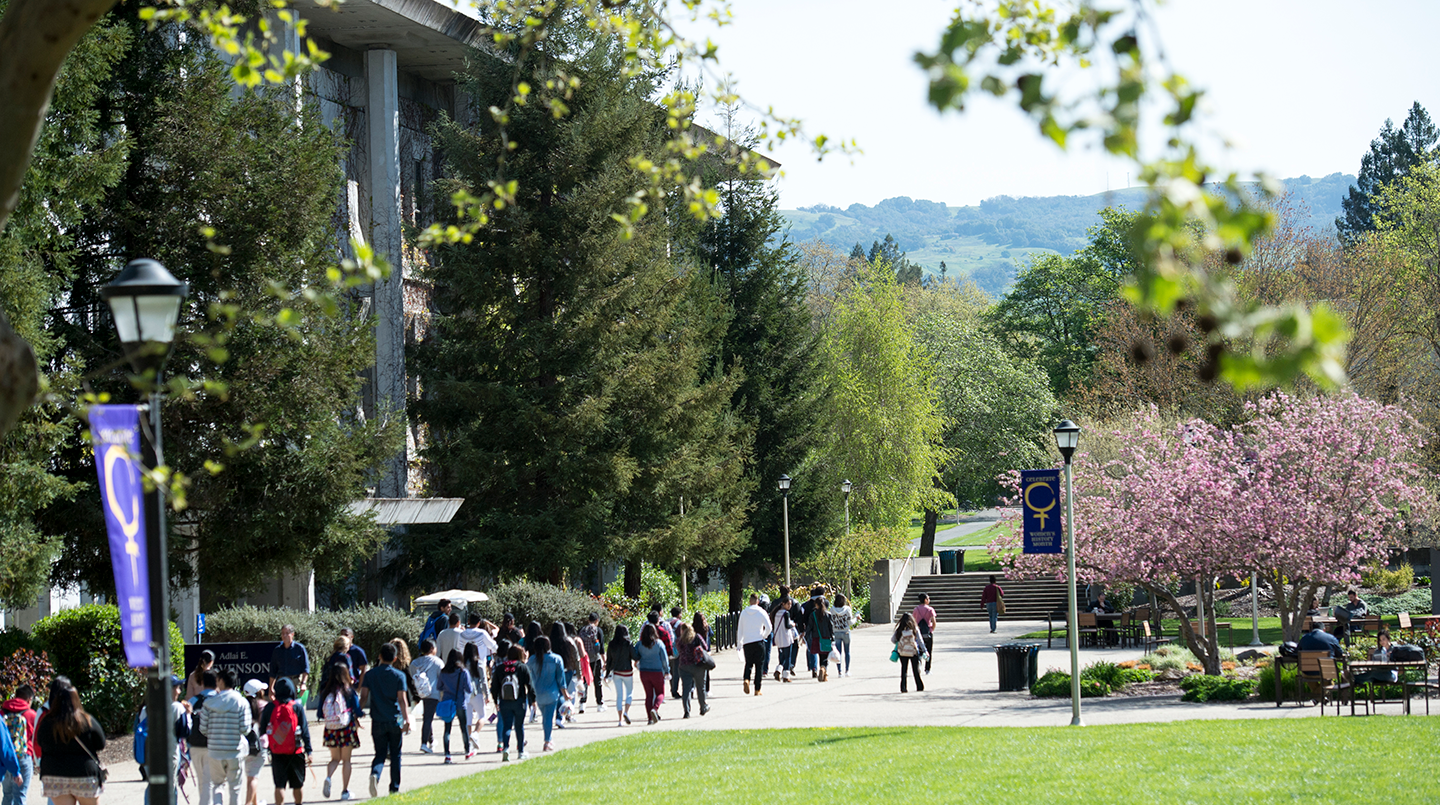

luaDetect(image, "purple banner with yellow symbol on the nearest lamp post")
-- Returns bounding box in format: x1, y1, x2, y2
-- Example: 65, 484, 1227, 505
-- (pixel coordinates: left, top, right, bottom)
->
89, 405, 156, 668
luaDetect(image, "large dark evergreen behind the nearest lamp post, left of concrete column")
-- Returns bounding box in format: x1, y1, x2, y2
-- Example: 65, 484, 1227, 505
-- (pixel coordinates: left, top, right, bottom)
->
43, 9, 402, 598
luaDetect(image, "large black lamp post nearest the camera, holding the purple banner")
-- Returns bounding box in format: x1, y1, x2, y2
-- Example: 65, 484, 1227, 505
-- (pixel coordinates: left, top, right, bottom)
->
101, 259, 190, 805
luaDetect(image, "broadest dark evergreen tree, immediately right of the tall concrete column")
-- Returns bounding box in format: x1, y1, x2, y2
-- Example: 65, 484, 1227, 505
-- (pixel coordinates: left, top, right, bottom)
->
396, 29, 747, 586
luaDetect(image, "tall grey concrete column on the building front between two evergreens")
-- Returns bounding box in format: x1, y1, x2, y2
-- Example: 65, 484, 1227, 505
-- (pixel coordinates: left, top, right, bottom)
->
364, 49, 408, 497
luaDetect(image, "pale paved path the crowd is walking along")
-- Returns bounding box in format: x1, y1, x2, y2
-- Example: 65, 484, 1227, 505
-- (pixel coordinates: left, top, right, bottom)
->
95, 622, 1336, 805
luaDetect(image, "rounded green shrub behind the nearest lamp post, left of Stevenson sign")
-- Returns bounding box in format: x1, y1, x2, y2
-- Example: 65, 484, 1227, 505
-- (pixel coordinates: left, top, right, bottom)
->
35, 603, 184, 734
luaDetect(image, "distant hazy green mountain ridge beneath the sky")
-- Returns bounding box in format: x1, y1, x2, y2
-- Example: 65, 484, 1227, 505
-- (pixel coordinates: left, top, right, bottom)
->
780, 173, 1355, 295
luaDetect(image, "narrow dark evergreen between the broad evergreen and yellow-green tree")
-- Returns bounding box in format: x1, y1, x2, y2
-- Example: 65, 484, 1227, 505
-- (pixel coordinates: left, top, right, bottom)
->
700, 151, 823, 611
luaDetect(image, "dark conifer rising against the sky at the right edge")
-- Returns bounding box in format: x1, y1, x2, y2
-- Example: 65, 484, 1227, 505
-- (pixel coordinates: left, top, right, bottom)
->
1335, 101, 1440, 242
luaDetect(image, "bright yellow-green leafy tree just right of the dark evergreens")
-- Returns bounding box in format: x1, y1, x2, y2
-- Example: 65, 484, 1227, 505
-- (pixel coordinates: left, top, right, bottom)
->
805, 264, 950, 529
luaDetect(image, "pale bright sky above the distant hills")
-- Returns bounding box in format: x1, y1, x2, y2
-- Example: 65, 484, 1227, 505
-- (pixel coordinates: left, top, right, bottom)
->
673, 0, 1440, 209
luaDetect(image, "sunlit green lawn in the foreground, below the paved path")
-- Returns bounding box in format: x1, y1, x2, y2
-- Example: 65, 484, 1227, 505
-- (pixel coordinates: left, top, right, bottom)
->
390, 719, 1440, 805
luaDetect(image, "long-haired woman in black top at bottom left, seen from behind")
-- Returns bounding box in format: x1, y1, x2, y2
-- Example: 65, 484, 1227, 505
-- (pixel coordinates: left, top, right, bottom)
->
35, 671, 104, 805
